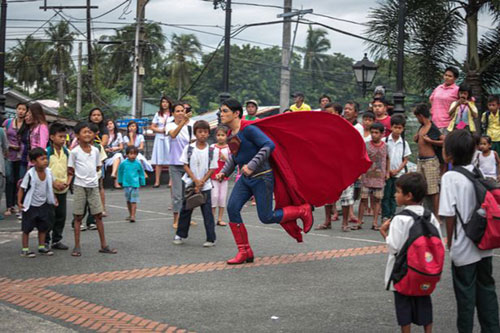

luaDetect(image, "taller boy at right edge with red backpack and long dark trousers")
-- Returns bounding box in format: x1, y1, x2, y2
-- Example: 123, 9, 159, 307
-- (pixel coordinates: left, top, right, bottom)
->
439, 130, 500, 332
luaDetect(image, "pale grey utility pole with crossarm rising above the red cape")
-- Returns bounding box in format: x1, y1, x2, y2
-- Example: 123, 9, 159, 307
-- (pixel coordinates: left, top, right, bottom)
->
277, 6, 313, 112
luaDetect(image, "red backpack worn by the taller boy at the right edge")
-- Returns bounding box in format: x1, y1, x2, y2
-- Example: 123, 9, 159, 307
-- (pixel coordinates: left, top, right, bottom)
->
453, 167, 500, 250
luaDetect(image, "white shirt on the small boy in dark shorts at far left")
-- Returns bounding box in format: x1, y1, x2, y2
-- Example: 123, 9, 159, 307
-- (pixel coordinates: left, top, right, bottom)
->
21, 167, 55, 212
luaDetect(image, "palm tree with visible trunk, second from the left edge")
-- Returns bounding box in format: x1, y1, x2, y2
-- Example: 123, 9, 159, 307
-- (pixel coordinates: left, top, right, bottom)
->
43, 21, 74, 108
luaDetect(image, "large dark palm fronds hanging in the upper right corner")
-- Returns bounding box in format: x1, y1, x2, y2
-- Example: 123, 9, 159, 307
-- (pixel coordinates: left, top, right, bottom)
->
367, 0, 500, 104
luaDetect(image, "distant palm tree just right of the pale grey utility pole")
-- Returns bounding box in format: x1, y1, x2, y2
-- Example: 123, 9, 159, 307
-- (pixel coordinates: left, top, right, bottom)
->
297, 25, 331, 82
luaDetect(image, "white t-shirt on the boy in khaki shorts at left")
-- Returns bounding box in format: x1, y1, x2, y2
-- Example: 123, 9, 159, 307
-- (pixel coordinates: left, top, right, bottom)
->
68, 146, 102, 188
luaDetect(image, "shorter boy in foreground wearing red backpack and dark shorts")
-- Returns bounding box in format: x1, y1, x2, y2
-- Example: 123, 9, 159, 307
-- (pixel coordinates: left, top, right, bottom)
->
380, 172, 444, 332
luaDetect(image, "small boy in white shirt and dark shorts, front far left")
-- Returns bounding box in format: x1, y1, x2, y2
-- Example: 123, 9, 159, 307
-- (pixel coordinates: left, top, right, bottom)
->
17, 148, 57, 258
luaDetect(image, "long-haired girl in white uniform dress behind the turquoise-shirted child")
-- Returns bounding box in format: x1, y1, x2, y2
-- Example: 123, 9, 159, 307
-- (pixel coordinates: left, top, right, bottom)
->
150, 97, 173, 188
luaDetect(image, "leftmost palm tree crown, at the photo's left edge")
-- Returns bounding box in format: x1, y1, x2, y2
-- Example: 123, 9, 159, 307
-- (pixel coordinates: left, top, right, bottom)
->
5, 36, 46, 90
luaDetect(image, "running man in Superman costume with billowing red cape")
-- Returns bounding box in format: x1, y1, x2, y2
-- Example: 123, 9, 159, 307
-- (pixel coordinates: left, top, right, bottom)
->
216, 99, 371, 265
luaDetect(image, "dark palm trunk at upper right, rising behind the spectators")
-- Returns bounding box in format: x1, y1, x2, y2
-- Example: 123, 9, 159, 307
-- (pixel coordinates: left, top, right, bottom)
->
465, 0, 483, 109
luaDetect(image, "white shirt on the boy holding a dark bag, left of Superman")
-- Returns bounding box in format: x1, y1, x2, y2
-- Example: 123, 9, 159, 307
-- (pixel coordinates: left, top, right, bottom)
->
179, 143, 218, 191
